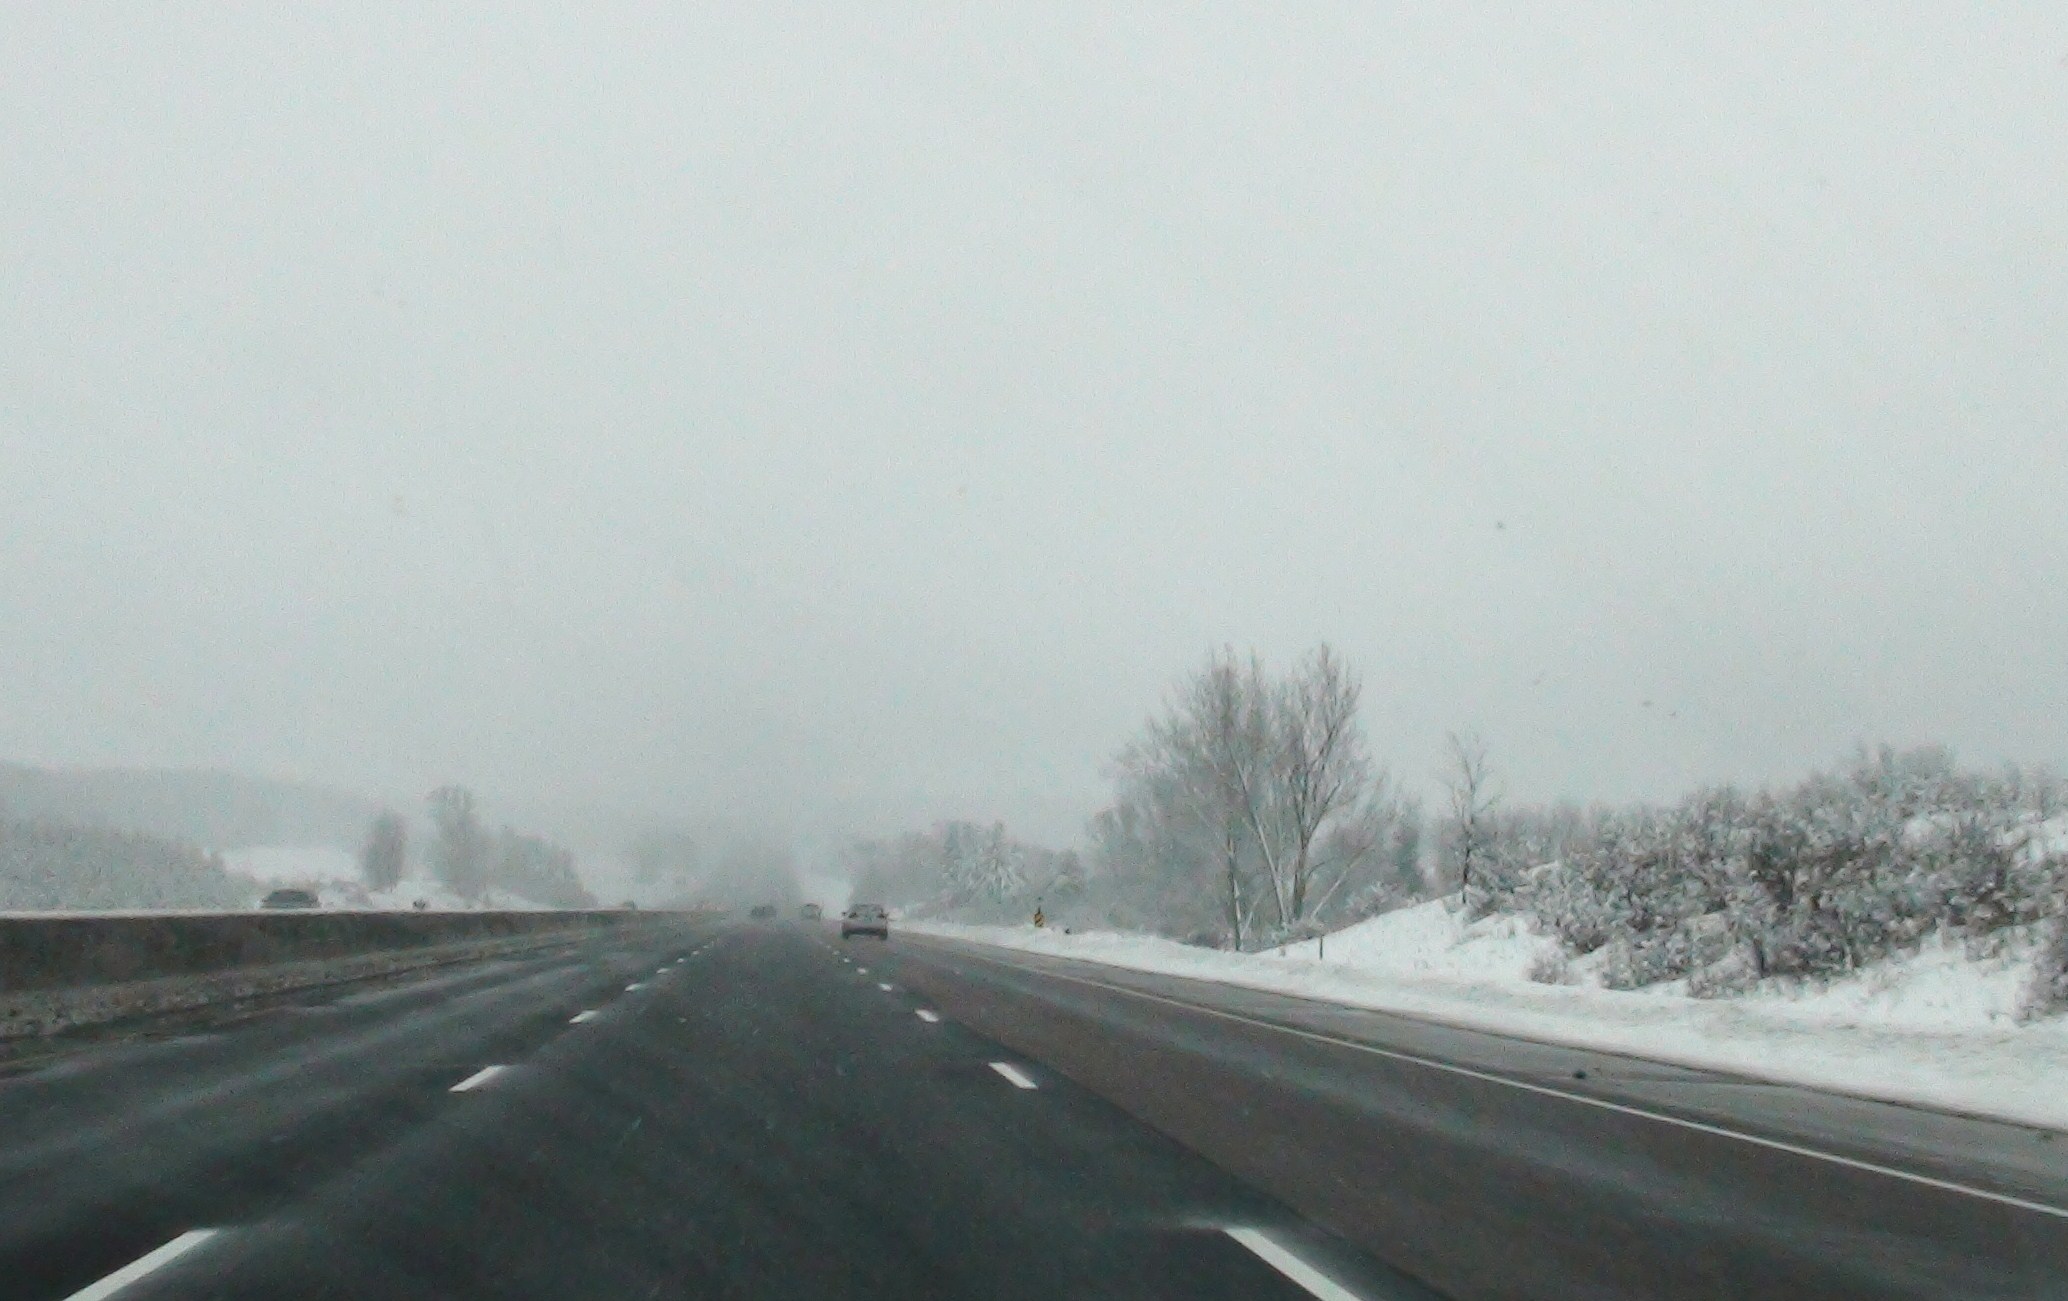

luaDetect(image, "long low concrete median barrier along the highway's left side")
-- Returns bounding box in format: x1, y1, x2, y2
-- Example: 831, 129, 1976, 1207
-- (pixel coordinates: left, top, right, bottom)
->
0, 910, 670, 1040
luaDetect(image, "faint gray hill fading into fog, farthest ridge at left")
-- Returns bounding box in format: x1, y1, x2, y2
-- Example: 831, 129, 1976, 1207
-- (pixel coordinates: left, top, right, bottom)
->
0, 763, 381, 850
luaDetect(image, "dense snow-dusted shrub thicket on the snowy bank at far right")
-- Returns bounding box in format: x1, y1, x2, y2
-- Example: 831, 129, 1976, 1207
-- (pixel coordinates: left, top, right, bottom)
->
1510, 749, 2068, 988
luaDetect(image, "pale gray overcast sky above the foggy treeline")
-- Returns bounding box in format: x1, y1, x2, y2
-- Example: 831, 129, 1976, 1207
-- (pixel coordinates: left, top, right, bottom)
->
0, 0, 2068, 840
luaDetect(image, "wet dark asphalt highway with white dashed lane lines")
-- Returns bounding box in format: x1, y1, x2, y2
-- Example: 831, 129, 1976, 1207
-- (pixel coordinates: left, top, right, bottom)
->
0, 925, 2068, 1301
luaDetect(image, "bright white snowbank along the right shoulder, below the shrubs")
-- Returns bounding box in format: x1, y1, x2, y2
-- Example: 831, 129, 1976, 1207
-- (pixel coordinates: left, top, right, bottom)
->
906, 902, 2068, 1129
